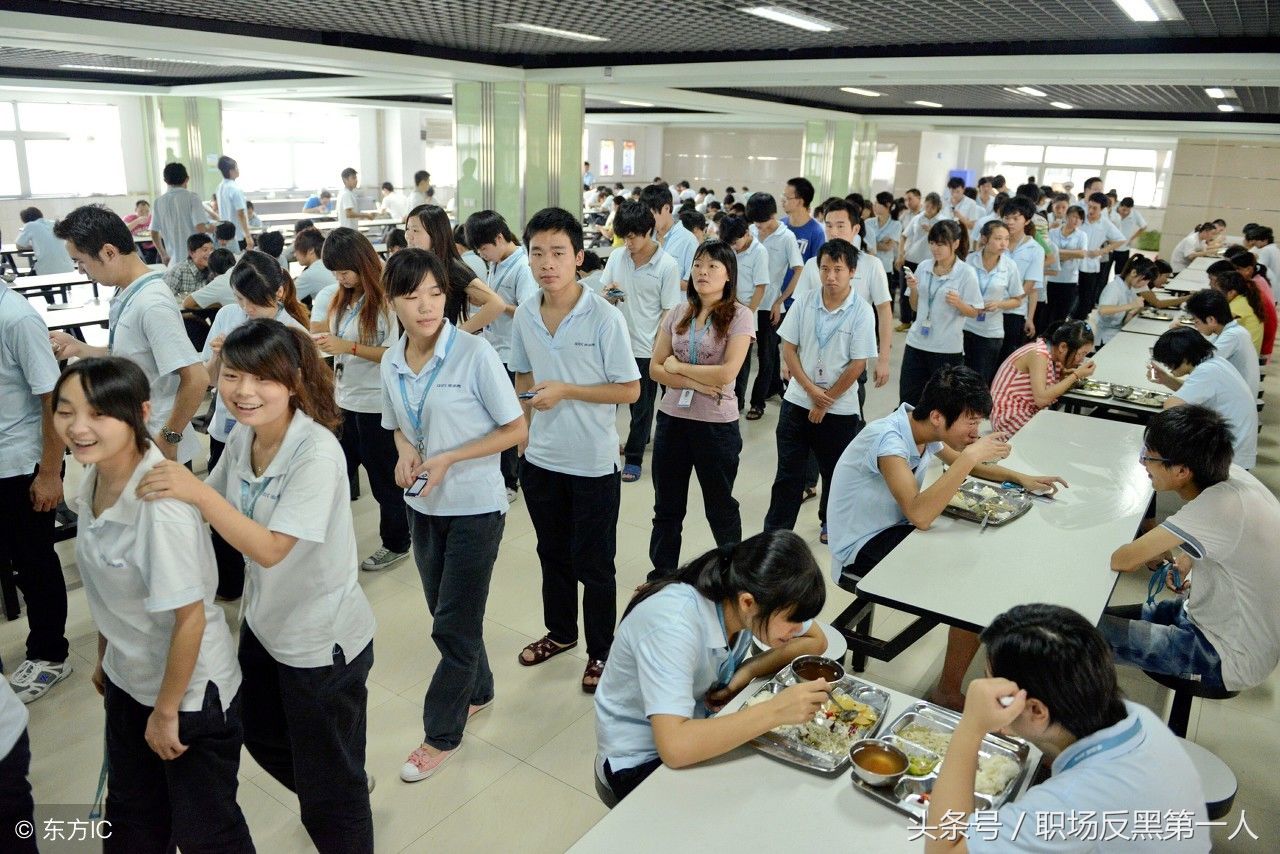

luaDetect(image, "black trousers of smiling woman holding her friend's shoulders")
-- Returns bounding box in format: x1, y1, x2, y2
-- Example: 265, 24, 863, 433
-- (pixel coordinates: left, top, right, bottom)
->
239, 622, 374, 854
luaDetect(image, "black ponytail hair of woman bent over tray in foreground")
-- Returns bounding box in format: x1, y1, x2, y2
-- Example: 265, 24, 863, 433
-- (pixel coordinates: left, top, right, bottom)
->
622, 530, 827, 636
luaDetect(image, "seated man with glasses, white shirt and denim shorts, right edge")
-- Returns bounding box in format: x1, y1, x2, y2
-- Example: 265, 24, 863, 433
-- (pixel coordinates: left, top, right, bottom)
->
1098, 405, 1280, 691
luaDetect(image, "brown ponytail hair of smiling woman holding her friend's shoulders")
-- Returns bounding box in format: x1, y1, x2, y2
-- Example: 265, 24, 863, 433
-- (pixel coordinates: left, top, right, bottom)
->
221, 317, 349, 430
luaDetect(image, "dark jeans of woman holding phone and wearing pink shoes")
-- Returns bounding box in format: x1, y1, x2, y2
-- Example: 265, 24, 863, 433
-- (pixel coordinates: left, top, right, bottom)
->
410, 510, 507, 750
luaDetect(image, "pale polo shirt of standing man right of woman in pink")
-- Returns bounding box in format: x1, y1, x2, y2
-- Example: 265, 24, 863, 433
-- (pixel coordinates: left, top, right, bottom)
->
778, 286, 878, 415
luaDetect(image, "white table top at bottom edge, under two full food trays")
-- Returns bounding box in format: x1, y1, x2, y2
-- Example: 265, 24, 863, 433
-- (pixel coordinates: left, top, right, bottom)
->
570, 680, 1039, 854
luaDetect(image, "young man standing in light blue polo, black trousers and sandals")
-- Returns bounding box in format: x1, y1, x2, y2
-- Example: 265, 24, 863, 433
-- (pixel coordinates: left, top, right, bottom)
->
511, 207, 640, 694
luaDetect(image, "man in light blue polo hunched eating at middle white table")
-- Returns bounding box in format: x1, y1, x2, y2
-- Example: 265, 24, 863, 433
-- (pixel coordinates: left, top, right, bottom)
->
827, 365, 1066, 709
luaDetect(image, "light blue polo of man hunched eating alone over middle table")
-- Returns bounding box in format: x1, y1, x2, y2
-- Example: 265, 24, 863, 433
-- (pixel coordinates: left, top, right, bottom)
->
827, 403, 942, 581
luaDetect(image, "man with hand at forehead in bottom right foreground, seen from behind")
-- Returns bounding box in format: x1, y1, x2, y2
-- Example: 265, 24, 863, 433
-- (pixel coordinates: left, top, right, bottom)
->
924, 604, 1211, 854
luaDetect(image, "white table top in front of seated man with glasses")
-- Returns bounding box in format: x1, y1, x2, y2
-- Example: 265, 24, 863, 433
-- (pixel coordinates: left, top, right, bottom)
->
858, 409, 1152, 629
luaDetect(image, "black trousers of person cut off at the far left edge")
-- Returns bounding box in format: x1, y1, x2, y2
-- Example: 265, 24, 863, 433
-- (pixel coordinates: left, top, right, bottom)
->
0, 466, 68, 665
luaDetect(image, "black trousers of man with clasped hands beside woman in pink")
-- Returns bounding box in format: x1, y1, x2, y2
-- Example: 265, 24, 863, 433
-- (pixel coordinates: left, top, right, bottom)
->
764, 401, 863, 531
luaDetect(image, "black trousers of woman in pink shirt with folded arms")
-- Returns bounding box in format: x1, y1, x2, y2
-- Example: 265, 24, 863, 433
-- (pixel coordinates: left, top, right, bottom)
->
649, 412, 742, 576
